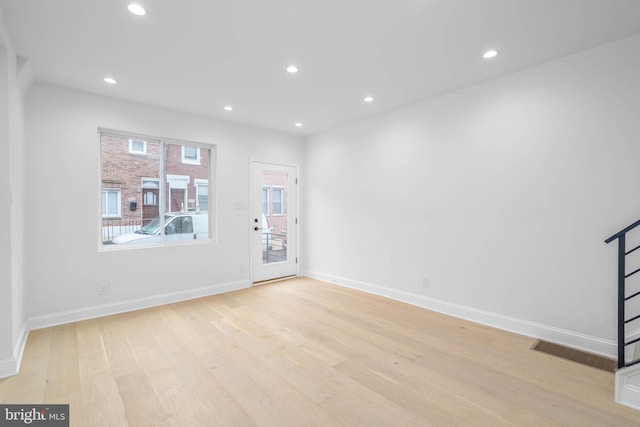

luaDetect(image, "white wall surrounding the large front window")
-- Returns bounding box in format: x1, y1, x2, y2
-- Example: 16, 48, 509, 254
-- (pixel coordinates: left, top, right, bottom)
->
26, 84, 302, 327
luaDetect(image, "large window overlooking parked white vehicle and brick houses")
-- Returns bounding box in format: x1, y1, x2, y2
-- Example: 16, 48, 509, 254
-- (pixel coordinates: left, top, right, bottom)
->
100, 131, 215, 248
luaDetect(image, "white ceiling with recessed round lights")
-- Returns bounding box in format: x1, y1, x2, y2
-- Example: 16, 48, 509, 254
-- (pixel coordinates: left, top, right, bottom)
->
0, 0, 640, 135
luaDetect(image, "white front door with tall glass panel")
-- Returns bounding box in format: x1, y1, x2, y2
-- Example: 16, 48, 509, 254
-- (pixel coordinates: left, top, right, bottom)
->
251, 161, 298, 283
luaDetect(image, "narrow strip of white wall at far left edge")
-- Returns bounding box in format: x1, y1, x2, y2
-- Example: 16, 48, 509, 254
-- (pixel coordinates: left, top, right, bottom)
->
0, 11, 27, 378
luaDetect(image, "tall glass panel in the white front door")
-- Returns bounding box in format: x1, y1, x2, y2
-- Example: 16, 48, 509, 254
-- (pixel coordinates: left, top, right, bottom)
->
262, 171, 289, 264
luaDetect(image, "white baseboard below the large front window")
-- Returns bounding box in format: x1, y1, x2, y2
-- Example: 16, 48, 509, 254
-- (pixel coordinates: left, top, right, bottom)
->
28, 280, 252, 330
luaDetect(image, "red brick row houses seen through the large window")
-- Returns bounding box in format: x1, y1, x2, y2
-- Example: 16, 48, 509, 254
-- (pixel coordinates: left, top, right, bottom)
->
100, 132, 211, 244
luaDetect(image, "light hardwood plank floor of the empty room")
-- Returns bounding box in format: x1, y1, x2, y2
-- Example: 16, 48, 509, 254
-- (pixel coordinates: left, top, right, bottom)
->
0, 278, 640, 427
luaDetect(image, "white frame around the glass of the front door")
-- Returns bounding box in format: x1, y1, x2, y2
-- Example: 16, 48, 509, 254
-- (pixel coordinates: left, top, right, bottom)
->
247, 158, 301, 286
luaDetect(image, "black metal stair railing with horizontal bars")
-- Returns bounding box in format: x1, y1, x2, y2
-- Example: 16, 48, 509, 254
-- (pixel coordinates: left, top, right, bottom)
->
605, 220, 640, 369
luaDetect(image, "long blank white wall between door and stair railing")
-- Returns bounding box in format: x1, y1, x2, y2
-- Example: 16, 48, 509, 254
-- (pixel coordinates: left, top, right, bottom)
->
303, 37, 640, 354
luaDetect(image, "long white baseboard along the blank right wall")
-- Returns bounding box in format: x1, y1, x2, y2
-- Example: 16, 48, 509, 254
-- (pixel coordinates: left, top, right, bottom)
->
305, 270, 617, 359
